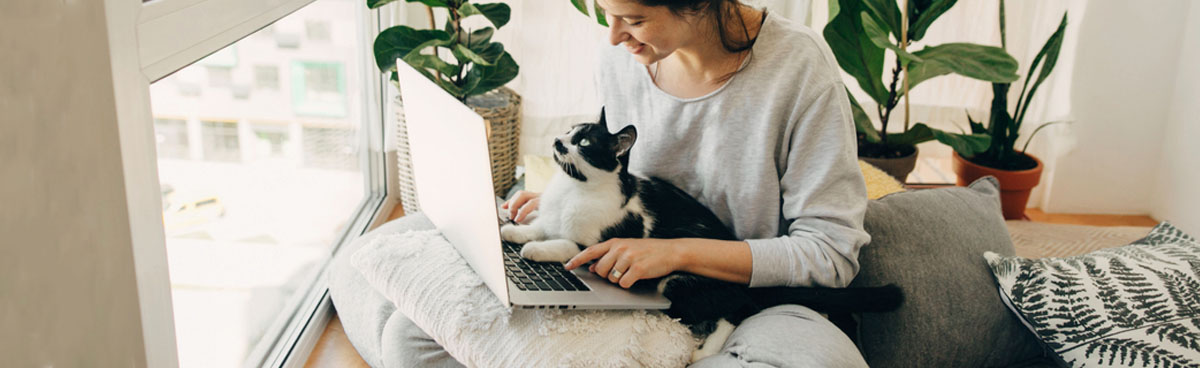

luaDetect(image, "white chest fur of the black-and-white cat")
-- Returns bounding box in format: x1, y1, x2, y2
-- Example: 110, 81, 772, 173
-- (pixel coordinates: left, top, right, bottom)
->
538, 173, 626, 247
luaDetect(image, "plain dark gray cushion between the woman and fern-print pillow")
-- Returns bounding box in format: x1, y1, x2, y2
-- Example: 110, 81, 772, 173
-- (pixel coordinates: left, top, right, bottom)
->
851, 176, 1043, 367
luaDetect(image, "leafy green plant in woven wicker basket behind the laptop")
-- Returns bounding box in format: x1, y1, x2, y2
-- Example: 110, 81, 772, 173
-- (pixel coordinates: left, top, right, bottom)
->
366, 0, 521, 213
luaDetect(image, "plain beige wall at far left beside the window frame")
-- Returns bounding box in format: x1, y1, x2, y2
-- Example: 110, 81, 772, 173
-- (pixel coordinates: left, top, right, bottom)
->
0, 0, 146, 367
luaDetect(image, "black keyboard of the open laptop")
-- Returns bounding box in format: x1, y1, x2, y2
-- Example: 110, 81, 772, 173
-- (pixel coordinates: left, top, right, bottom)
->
504, 242, 592, 291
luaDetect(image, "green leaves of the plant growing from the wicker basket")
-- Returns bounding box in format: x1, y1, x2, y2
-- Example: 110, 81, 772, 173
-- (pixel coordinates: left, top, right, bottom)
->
366, 0, 520, 101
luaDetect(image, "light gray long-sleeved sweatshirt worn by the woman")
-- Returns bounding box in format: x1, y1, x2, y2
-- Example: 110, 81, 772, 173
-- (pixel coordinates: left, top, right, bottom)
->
596, 13, 870, 288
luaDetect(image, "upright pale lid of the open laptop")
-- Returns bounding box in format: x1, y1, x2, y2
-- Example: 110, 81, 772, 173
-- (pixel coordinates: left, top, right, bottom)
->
396, 61, 510, 304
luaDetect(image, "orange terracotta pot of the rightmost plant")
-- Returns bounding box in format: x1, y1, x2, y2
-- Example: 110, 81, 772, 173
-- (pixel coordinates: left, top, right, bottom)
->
953, 152, 1043, 219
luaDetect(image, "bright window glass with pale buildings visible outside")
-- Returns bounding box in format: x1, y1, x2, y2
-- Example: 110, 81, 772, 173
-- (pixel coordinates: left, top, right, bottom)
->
150, 0, 362, 367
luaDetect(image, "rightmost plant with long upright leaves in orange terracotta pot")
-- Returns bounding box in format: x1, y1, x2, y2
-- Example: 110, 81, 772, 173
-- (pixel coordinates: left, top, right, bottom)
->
953, 0, 1067, 219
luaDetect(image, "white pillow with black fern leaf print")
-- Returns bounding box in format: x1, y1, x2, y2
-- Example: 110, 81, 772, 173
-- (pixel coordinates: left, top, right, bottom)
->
984, 222, 1200, 367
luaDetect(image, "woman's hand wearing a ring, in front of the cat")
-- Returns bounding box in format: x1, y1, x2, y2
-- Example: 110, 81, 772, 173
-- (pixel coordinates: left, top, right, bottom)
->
565, 239, 684, 289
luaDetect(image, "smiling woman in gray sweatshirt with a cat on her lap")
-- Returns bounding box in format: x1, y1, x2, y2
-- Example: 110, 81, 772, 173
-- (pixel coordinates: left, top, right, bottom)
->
505, 0, 870, 367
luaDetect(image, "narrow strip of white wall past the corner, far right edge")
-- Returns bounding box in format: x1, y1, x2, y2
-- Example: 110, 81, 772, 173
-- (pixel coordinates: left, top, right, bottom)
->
1151, 2, 1200, 234
